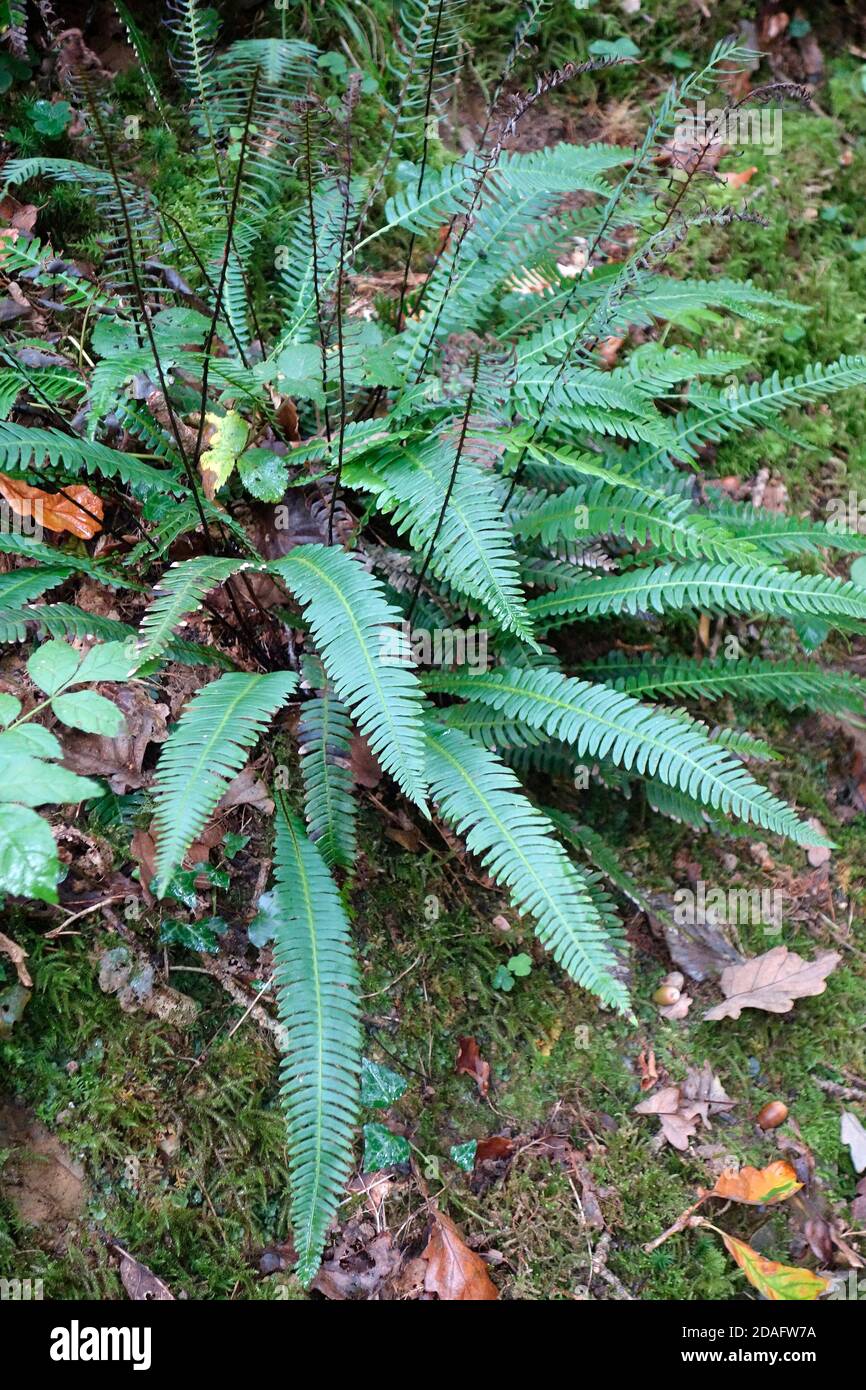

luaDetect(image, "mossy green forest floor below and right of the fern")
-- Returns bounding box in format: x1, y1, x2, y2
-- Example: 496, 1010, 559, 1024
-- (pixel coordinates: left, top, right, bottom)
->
0, 6, 866, 1300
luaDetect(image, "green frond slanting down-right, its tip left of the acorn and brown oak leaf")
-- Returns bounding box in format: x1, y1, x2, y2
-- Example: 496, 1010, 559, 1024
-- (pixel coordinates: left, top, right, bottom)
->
427, 727, 630, 1013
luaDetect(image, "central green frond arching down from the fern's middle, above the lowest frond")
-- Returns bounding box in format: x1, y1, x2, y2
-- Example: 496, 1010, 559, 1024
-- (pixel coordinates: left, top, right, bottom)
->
268, 545, 427, 809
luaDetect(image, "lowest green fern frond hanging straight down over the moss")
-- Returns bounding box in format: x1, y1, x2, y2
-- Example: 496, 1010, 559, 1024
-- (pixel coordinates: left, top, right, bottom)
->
274, 792, 361, 1287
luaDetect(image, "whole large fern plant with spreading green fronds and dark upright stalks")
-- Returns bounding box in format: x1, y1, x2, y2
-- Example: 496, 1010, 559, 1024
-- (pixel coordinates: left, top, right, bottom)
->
0, 0, 866, 1283
